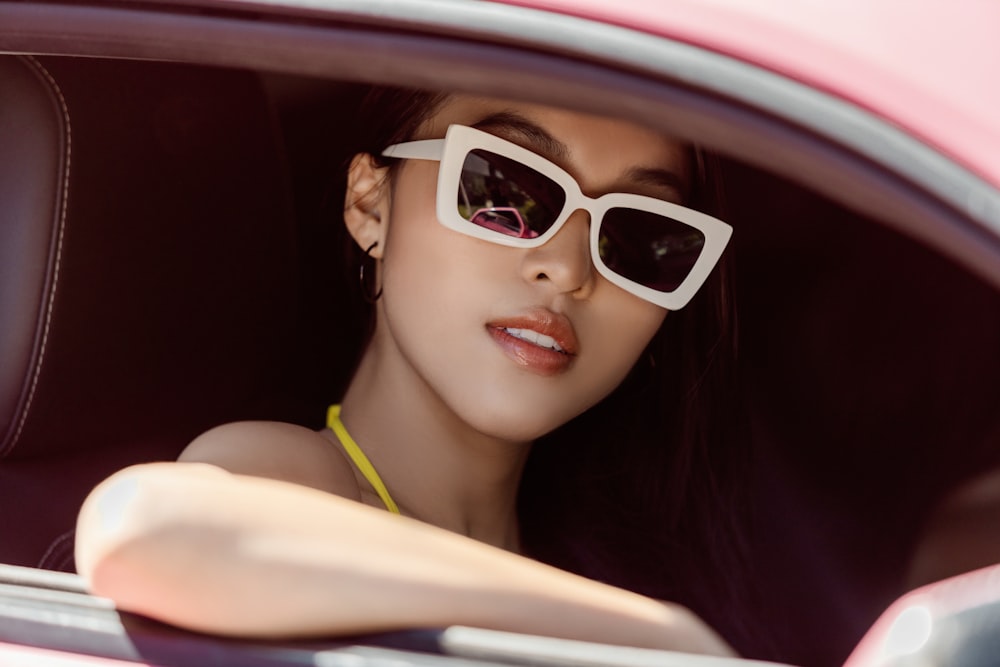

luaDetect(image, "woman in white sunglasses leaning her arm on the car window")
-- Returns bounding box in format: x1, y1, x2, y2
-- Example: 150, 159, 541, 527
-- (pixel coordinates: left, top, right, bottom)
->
77, 91, 748, 654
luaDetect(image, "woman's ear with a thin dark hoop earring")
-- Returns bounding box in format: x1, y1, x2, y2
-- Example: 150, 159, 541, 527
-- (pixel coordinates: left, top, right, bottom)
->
344, 153, 389, 258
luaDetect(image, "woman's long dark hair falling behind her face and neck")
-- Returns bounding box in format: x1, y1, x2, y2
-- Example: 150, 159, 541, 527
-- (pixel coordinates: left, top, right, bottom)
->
339, 88, 748, 647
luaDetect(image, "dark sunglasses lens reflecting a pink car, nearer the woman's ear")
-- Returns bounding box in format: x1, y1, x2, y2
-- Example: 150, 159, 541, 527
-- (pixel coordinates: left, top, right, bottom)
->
457, 149, 566, 239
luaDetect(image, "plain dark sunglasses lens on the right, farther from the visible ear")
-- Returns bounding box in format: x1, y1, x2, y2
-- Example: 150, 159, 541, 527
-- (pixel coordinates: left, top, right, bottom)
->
598, 208, 705, 292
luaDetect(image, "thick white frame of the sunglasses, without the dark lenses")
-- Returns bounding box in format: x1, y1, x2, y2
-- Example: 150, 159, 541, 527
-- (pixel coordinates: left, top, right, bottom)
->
382, 125, 733, 310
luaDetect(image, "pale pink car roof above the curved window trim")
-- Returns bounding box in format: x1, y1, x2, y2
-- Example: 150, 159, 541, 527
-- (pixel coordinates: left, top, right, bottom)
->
500, 0, 1000, 185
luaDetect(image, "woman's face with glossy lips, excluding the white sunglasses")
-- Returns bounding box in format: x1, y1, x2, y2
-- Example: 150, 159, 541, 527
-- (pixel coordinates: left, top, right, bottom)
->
356, 96, 687, 441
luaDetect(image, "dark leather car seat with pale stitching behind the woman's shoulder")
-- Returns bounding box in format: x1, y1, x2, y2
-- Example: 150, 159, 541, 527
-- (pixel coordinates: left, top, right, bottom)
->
0, 56, 298, 570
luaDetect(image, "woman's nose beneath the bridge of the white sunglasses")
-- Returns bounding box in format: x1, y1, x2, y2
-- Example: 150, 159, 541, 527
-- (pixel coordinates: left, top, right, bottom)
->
522, 210, 596, 298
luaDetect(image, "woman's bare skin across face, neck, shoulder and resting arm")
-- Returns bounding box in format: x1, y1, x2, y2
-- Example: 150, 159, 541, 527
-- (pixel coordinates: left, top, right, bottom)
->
76, 96, 731, 654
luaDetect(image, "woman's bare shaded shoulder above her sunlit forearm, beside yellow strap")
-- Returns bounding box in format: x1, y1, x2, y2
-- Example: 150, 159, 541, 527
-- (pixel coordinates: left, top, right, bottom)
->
178, 421, 361, 500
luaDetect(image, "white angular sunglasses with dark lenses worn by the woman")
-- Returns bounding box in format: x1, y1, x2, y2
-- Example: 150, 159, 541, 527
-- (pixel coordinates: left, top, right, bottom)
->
382, 125, 733, 310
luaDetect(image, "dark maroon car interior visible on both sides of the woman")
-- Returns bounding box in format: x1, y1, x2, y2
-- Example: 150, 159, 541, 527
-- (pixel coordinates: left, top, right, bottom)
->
0, 36, 1000, 665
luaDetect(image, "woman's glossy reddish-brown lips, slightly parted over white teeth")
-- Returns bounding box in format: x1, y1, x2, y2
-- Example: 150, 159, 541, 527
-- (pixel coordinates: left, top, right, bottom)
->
486, 310, 578, 375
